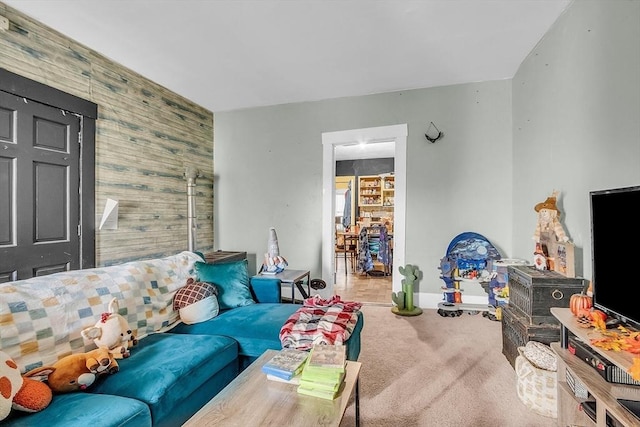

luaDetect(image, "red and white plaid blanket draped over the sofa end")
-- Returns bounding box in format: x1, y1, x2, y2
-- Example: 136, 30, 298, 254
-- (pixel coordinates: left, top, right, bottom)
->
280, 295, 362, 350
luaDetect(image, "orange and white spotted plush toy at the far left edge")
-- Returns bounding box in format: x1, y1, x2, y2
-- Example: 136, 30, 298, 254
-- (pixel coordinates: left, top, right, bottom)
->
0, 351, 53, 421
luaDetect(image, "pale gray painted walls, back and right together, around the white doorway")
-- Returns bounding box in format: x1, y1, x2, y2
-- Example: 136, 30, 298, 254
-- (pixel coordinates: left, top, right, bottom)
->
215, 0, 640, 307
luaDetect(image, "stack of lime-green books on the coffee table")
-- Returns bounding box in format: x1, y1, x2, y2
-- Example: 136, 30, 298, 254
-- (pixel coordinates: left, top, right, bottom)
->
298, 344, 347, 400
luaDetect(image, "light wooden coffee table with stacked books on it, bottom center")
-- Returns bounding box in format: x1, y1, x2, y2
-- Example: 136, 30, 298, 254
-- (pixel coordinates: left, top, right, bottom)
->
184, 350, 361, 427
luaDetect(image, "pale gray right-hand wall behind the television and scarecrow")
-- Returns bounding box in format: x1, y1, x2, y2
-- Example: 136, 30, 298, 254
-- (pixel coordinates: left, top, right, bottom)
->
512, 0, 640, 279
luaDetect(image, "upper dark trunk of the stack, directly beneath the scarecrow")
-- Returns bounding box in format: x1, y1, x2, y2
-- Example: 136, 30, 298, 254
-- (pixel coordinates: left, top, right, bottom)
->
508, 265, 586, 324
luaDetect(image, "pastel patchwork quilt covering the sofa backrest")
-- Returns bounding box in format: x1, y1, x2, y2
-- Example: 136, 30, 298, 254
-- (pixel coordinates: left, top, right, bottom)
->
0, 252, 202, 372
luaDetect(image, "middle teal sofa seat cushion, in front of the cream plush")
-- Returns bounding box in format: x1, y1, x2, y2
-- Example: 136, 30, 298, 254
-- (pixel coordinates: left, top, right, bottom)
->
89, 333, 238, 420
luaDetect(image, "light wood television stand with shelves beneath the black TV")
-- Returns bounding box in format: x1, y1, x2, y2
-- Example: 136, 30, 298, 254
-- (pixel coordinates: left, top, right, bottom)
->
551, 307, 640, 427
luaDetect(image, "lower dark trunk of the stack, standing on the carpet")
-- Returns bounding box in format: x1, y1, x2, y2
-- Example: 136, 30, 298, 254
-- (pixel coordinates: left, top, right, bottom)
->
502, 306, 560, 368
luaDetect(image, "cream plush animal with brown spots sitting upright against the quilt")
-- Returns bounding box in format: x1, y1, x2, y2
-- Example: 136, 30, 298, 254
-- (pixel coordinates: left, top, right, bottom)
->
81, 298, 138, 359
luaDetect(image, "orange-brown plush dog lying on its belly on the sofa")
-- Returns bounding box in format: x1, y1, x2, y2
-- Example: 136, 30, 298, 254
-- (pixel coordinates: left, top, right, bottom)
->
25, 348, 120, 393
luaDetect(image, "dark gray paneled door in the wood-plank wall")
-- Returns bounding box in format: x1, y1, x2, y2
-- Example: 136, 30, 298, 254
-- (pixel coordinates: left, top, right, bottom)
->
0, 91, 81, 281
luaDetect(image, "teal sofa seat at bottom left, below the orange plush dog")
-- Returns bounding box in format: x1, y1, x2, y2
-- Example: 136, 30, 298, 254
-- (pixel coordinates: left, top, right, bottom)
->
0, 394, 151, 427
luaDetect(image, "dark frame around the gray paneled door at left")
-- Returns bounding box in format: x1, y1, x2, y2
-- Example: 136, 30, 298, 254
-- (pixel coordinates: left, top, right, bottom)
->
0, 68, 98, 269
